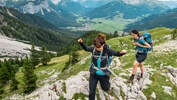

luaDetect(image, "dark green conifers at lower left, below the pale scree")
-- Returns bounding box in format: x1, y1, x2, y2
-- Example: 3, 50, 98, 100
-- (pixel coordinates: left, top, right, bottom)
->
0, 44, 53, 98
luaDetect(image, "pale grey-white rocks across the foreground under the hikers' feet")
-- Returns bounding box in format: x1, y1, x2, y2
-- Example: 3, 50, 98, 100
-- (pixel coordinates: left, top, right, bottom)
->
6, 66, 177, 100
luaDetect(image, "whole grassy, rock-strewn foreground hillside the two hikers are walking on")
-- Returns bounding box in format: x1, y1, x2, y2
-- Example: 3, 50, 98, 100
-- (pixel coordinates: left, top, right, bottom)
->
1, 28, 177, 100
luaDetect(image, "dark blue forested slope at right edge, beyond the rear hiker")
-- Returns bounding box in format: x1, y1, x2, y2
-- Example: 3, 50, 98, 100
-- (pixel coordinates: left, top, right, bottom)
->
125, 9, 177, 31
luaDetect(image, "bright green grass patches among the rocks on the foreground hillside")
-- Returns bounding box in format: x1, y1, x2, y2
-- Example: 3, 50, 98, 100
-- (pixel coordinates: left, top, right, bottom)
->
5, 28, 177, 100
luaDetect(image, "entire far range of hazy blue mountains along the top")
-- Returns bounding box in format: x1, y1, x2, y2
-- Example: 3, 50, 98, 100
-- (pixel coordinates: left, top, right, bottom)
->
0, 0, 168, 28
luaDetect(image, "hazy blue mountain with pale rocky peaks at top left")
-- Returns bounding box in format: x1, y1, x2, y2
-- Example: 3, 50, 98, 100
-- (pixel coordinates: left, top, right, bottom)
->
1, 0, 84, 27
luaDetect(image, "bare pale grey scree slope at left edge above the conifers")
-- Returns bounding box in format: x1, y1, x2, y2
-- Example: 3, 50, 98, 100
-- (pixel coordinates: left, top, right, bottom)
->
0, 34, 39, 60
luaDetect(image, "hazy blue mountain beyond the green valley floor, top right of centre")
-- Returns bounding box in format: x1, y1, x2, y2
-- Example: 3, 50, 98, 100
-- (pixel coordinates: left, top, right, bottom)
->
88, 0, 168, 19
